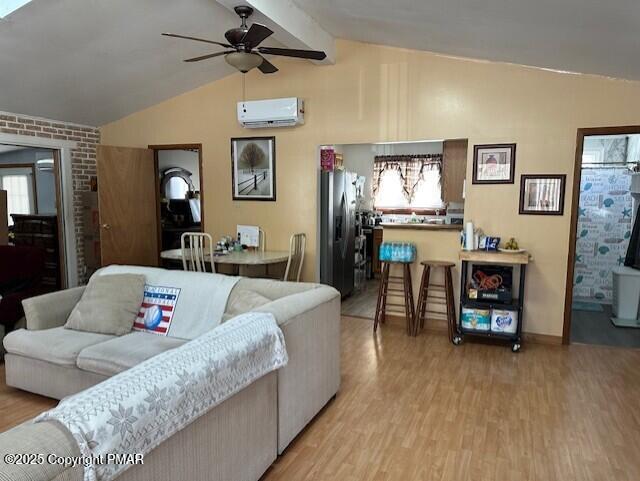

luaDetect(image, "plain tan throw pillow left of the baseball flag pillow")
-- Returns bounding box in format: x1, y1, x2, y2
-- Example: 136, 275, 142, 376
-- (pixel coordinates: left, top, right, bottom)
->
65, 274, 145, 336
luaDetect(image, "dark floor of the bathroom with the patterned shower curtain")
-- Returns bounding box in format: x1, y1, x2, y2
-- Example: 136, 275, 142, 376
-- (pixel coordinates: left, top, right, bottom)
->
571, 305, 640, 348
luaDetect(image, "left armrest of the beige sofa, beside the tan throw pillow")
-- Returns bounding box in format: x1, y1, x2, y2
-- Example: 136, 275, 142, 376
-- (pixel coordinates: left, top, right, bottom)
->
22, 286, 85, 331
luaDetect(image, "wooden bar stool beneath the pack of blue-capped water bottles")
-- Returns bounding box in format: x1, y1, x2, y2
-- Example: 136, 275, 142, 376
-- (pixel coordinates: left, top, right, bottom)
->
373, 261, 416, 336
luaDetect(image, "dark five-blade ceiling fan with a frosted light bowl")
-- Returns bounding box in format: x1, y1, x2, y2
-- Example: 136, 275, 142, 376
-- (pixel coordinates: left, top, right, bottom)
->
162, 5, 327, 73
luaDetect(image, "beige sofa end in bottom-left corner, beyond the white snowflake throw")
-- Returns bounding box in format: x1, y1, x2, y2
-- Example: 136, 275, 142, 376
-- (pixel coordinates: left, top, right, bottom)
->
0, 421, 84, 481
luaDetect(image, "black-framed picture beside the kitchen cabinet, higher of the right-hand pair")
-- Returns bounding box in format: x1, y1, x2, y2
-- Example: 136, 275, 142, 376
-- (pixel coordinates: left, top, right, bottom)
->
473, 144, 516, 184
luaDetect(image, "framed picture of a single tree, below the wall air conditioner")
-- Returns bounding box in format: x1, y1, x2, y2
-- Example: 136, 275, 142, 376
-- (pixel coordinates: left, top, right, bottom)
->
231, 137, 276, 200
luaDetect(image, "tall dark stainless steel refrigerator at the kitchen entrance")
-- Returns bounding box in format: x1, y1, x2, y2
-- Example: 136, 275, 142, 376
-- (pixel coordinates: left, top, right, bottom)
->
320, 170, 358, 297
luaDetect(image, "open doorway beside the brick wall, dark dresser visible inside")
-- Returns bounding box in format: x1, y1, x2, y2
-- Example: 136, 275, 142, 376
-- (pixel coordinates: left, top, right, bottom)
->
0, 144, 67, 331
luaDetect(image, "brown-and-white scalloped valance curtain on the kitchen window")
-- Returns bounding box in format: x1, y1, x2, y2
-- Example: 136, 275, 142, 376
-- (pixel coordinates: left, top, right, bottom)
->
372, 154, 442, 203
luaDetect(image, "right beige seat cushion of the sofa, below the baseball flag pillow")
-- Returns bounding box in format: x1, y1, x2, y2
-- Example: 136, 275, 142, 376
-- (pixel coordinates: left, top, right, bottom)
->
77, 332, 187, 376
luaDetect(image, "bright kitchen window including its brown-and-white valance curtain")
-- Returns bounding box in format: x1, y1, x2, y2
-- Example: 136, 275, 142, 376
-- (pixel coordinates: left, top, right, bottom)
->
373, 154, 444, 213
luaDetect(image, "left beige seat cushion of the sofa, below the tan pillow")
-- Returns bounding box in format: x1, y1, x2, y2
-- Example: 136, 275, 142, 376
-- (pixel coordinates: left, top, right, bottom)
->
4, 327, 113, 367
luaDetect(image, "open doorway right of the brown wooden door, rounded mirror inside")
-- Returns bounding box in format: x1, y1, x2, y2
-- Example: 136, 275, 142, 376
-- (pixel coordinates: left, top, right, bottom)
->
149, 144, 204, 264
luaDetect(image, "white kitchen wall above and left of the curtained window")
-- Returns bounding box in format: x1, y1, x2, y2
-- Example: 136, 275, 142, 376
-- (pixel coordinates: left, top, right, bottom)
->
336, 142, 442, 210
